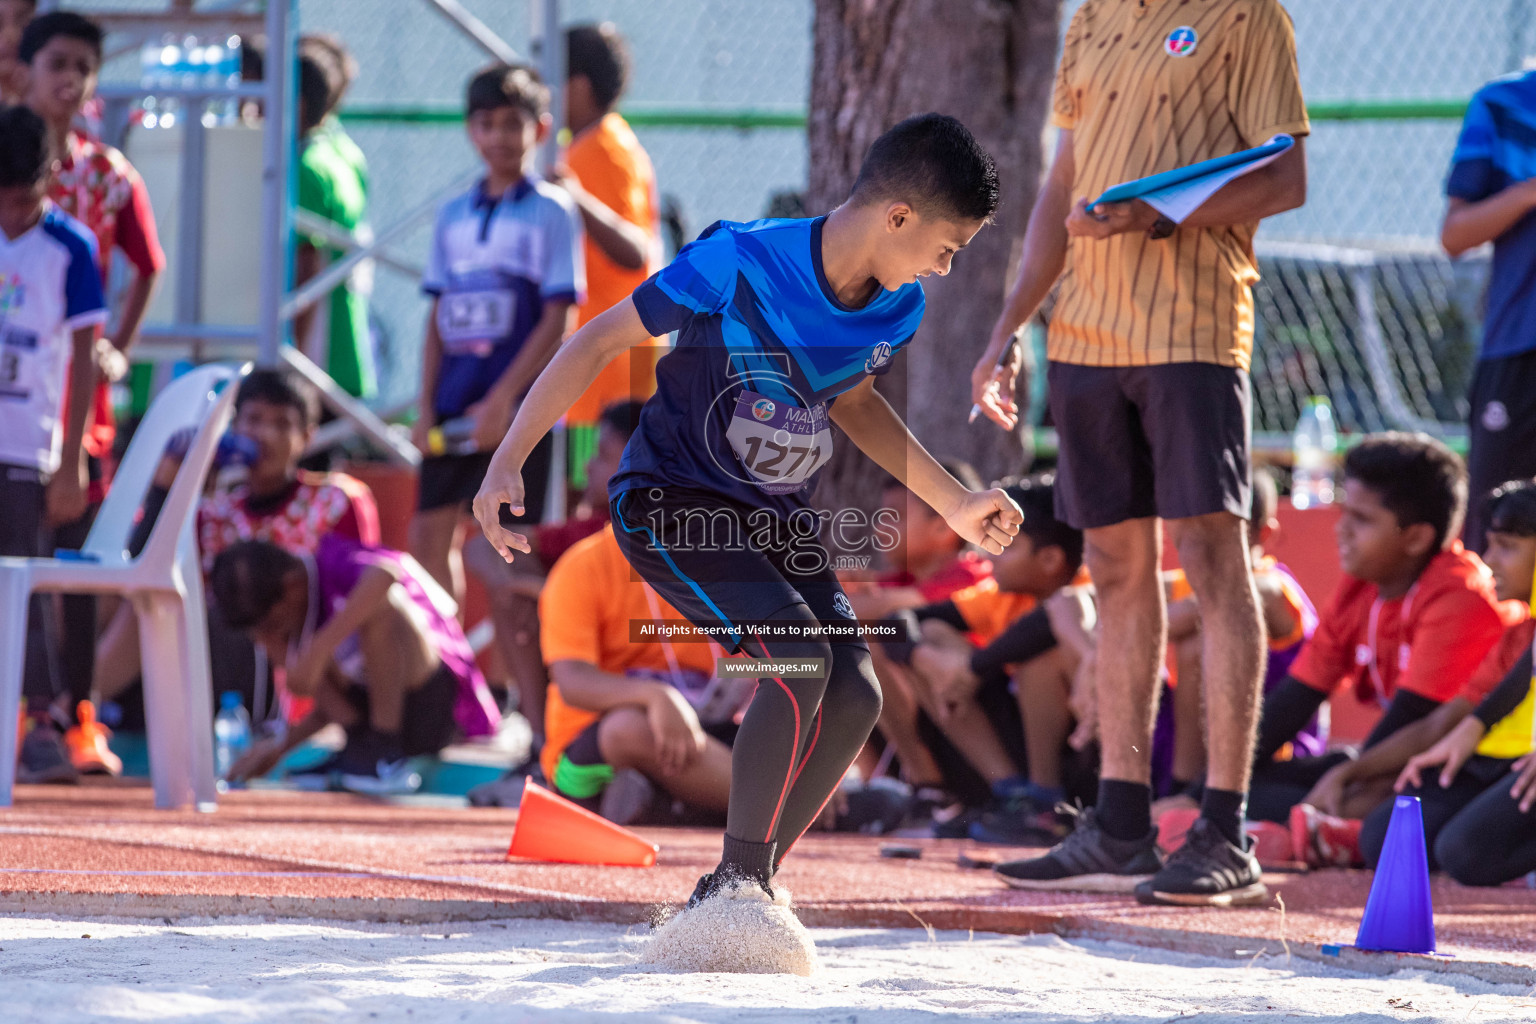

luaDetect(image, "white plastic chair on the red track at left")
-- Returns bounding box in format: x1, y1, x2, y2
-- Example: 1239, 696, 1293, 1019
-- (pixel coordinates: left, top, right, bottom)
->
0, 364, 250, 809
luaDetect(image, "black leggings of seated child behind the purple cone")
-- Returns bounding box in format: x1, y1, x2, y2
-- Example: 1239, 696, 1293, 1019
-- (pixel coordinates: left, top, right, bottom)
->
1359, 757, 1536, 886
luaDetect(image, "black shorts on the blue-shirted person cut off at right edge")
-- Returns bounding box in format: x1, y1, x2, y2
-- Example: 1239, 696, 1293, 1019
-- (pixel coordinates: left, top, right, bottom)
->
1462, 352, 1536, 551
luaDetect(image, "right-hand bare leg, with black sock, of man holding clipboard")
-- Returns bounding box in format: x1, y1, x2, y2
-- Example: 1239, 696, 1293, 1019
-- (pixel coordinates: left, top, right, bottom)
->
1170, 511, 1264, 844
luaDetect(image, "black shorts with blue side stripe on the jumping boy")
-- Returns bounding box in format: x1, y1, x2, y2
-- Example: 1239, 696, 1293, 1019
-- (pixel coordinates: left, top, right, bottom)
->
611, 487, 863, 657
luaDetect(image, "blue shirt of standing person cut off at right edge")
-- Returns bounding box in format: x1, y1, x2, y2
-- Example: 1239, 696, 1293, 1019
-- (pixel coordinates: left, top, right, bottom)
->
1445, 71, 1536, 359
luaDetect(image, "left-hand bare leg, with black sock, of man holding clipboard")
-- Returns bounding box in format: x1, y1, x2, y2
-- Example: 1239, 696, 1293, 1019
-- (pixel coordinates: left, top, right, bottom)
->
1084, 517, 1167, 840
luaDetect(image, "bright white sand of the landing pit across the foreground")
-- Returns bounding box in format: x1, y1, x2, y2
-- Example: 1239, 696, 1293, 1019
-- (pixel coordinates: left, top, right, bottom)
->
0, 917, 1536, 1024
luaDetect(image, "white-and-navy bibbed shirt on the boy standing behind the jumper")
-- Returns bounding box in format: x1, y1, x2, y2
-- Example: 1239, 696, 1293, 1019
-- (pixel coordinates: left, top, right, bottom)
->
421, 178, 587, 422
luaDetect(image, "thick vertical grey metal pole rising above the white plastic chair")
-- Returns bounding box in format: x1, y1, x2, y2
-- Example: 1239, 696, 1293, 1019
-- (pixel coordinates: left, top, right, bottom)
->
257, 0, 295, 367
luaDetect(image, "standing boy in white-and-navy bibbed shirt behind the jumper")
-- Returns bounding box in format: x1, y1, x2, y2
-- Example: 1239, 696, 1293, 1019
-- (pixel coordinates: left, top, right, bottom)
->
410, 64, 587, 600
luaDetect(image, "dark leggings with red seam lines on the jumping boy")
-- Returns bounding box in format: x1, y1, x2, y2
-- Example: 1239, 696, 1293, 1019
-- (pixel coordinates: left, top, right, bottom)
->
725, 605, 880, 867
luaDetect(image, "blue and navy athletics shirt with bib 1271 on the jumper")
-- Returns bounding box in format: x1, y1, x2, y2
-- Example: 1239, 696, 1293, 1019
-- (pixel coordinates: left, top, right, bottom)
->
608, 218, 923, 517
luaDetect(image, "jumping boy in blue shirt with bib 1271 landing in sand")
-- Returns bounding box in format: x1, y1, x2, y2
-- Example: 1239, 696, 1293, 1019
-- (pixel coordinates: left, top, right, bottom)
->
475, 114, 1023, 903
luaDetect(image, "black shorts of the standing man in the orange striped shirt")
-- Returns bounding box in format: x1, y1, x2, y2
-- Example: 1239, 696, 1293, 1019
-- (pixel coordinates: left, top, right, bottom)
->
1046, 362, 1253, 530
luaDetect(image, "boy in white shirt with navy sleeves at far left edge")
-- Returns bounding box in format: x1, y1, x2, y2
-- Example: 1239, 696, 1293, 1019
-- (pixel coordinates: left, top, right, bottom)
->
0, 106, 106, 783
